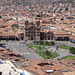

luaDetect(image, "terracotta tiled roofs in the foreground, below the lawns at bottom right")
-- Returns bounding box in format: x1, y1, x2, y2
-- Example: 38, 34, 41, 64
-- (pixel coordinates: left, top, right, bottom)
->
27, 59, 75, 75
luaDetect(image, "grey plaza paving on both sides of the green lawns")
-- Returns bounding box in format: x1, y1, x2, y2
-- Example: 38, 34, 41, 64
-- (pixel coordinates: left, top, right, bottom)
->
0, 41, 75, 59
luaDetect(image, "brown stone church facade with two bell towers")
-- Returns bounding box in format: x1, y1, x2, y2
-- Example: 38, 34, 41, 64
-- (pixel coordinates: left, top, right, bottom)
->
25, 20, 40, 40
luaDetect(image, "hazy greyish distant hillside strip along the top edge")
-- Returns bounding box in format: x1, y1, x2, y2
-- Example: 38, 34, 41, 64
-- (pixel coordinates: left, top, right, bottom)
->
0, 0, 75, 5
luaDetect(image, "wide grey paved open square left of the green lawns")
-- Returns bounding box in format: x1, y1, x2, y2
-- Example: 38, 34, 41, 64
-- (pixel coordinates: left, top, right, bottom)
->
0, 41, 43, 60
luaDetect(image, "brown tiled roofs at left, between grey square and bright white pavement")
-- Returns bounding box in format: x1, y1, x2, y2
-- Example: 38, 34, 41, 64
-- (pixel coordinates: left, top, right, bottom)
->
0, 47, 27, 69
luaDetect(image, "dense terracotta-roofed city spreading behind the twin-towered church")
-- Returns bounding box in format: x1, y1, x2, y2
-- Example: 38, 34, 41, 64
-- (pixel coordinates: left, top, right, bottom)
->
0, 0, 75, 40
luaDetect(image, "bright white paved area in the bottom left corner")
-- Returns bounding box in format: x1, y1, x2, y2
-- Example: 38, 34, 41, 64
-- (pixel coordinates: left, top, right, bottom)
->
0, 60, 32, 75
